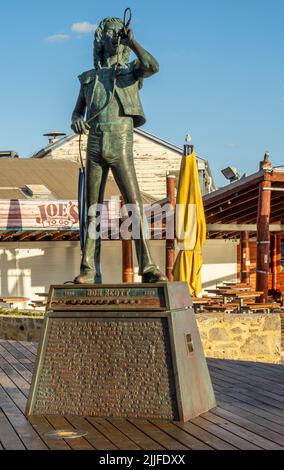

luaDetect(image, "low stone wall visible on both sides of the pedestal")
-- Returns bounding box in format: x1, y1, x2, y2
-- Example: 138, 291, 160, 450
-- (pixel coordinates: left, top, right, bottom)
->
0, 313, 281, 364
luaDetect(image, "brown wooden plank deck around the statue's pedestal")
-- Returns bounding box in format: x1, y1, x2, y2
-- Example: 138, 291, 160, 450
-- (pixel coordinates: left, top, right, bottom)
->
0, 340, 284, 450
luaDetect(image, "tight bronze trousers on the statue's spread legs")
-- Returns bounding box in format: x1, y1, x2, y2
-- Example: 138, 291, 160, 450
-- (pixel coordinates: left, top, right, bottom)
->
81, 124, 155, 282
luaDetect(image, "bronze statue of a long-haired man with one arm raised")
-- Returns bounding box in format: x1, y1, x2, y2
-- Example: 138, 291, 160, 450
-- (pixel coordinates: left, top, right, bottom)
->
71, 17, 167, 284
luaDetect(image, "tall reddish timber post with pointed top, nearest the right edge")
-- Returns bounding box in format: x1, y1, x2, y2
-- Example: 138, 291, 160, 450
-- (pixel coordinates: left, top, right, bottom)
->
256, 153, 272, 303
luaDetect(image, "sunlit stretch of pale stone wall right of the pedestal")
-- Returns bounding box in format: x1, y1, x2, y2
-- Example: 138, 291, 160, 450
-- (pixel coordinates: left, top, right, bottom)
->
196, 313, 281, 364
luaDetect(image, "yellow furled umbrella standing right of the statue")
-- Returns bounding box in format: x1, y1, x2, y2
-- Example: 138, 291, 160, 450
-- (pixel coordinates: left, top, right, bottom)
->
173, 145, 206, 296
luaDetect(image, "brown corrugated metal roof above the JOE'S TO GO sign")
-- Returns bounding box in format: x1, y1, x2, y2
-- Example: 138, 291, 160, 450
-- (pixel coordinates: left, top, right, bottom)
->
0, 158, 155, 204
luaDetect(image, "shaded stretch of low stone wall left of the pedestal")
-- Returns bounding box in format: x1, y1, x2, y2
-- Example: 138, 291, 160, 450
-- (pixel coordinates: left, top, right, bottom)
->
0, 315, 43, 342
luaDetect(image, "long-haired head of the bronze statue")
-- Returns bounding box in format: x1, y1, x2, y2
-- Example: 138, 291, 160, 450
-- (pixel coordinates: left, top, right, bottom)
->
94, 17, 130, 69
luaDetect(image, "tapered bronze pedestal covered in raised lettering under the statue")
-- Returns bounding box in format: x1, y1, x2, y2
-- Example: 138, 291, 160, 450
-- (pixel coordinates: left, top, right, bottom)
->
26, 282, 216, 421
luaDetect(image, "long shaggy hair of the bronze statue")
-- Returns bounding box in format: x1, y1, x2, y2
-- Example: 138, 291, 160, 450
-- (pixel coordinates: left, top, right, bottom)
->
94, 16, 130, 69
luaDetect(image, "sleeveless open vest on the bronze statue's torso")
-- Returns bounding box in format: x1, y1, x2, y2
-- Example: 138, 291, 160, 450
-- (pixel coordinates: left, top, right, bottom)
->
79, 62, 146, 127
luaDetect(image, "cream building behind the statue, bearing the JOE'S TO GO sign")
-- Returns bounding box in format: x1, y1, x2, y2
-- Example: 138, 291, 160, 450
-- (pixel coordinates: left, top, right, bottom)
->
0, 130, 237, 308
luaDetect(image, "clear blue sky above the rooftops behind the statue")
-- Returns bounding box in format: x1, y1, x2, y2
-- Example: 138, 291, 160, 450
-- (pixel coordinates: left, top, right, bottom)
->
0, 0, 284, 184
